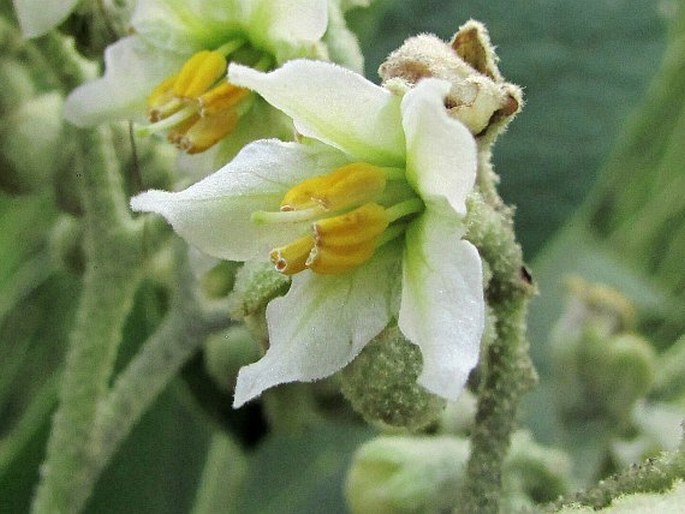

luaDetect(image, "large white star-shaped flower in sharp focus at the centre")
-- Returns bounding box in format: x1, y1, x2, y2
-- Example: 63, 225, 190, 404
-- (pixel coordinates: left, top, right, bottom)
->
131, 60, 484, 407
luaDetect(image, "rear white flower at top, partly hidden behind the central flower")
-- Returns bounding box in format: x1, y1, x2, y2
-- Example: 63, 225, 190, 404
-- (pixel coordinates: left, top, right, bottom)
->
65, 0, 361, 164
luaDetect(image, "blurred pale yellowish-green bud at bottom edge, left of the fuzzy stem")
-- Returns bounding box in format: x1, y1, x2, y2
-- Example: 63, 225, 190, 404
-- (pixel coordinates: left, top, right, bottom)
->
345, 436, 469, 514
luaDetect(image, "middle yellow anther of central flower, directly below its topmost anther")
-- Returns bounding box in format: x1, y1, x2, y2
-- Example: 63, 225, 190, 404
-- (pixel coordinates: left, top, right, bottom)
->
313, 203, 389, 247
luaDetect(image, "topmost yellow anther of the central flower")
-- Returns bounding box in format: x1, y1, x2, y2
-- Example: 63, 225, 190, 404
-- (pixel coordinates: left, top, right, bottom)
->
281, 162, 387, 211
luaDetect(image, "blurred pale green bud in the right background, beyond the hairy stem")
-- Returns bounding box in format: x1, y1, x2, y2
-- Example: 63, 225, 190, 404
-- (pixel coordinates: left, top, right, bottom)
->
552, 278, 656, 423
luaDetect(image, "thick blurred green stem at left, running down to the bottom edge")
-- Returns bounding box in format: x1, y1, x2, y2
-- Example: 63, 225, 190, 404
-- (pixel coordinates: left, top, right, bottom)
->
33, 125, 142, 513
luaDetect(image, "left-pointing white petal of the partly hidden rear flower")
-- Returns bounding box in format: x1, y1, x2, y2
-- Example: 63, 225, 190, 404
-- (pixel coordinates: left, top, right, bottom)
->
64, 36, 185, 127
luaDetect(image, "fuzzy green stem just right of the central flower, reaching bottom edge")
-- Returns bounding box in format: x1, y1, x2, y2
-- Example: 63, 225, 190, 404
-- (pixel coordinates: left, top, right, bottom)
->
456, 152, 536, 514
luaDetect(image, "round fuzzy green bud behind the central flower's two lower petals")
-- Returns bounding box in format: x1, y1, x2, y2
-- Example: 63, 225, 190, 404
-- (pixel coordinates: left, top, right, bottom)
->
341, 326, 445, 431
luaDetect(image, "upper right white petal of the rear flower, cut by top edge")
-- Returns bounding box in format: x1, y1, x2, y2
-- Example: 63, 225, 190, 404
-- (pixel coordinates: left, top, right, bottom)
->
248, 0, 328, 46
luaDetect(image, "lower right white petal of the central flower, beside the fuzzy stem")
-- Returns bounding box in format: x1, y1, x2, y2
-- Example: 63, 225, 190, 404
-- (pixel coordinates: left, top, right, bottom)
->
398, 209, 485, 400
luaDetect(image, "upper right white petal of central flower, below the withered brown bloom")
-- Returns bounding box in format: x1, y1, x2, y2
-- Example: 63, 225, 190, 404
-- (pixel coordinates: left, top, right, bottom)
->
402, 79, 477, 214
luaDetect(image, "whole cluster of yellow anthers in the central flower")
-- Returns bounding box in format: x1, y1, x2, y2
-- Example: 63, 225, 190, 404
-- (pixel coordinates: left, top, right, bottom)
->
252, 162, 423, 275
